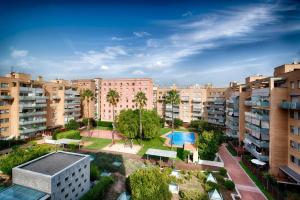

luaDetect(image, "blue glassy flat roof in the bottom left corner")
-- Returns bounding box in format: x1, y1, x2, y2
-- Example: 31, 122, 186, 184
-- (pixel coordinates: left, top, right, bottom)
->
0, 185, 49, 200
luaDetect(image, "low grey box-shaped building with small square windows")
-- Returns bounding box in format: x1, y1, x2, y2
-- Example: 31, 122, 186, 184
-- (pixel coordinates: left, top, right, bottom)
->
12, 151, 90, 200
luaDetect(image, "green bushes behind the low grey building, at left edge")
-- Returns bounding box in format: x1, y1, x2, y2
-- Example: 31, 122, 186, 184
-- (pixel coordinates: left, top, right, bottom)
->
0, 146, 50, 175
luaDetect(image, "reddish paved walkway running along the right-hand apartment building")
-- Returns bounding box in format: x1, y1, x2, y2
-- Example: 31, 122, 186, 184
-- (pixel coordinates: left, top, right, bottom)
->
219, 145, 266, 200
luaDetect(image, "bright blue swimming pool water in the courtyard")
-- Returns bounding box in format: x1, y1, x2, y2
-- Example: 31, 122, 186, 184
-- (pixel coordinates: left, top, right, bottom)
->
167, 131, 195, 146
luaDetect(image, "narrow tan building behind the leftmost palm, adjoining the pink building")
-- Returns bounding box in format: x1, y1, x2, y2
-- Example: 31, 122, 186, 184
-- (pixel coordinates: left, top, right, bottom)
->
72, 79, 98, 119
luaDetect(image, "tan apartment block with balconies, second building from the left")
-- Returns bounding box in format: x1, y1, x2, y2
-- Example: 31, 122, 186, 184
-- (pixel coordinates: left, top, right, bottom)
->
43, 79, 81, 127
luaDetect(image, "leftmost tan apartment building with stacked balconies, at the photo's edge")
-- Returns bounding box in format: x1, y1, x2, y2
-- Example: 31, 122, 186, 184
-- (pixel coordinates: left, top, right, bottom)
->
0, 72, 48, 138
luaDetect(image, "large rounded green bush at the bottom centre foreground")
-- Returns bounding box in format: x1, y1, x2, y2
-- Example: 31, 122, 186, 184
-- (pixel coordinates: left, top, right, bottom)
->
128, 167, 172, 200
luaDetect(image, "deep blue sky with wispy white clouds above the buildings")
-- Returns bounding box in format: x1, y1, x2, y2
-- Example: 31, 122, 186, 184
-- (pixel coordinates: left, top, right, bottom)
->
0, 0, 300, 86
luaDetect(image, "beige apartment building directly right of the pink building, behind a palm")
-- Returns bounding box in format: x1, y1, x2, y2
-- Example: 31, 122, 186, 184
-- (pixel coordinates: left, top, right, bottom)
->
154, 85, 207, 123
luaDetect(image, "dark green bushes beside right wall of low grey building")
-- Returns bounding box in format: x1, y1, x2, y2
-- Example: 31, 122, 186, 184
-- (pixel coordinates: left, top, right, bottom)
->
80, 177, 114, 200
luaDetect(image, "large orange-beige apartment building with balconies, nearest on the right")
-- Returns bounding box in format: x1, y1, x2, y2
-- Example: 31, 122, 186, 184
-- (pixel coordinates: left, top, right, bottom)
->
226, 64, 300, 184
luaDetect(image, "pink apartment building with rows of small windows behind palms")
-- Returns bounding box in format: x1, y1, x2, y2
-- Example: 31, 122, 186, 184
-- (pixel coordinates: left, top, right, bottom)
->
100, 78, 153, 121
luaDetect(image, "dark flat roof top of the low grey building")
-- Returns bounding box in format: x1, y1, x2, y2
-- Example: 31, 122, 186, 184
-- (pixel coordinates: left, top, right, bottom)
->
19, 151, 86, 175
